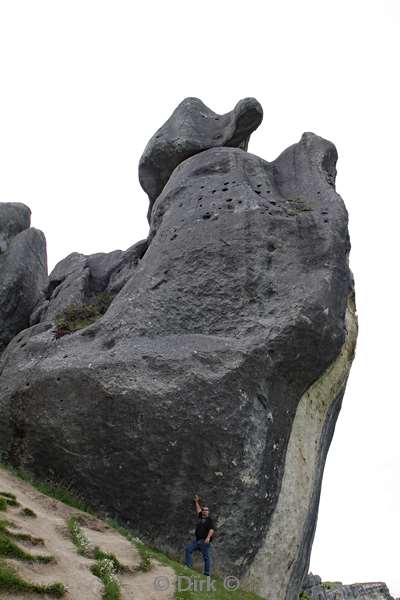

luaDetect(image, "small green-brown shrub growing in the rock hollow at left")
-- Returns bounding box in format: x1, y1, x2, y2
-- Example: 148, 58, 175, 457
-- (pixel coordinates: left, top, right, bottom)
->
56, 292, 113, 338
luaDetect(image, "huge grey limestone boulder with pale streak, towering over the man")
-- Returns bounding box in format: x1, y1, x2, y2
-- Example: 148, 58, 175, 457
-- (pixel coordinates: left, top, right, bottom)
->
0, 100, 357, 600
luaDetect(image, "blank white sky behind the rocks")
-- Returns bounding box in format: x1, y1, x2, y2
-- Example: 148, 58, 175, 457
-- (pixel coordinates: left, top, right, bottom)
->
0, 0, 400, 595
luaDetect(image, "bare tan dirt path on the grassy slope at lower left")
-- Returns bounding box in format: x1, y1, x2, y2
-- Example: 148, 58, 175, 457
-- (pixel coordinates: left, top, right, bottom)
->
0, 468, 175, 600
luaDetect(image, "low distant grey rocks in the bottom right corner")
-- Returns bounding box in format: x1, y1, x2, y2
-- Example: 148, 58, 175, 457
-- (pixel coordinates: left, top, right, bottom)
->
303, 574, 393, 600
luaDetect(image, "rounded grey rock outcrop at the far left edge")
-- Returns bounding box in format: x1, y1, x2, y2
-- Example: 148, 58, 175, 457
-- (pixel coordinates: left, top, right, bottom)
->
0, 203, 47, 353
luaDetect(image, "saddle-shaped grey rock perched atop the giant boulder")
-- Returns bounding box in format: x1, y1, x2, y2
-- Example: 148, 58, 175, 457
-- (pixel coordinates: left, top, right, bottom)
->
139, 98, 263, 219
